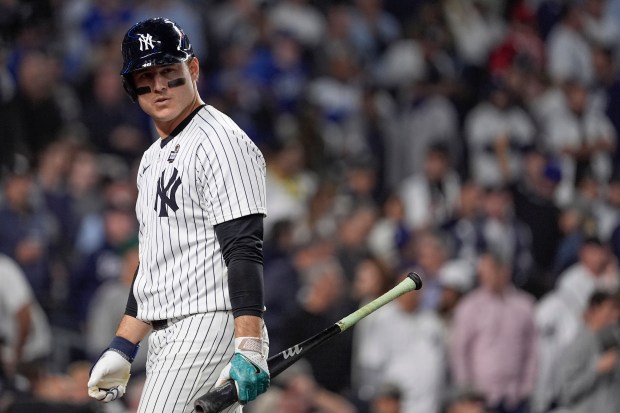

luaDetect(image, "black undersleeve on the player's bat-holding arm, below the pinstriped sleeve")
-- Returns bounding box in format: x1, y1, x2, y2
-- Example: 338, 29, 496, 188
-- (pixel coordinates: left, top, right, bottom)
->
215, 214, 265, 317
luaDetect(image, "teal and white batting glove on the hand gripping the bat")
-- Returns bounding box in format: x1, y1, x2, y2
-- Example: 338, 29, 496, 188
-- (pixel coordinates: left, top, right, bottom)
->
215, 337, 269, 404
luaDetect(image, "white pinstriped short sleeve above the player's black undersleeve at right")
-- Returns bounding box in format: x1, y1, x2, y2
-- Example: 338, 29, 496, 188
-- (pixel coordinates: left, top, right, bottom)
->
196, 128, 267, 226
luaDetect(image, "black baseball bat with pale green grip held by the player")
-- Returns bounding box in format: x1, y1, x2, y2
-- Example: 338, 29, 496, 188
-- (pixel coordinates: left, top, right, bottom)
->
194, 272, 422, 413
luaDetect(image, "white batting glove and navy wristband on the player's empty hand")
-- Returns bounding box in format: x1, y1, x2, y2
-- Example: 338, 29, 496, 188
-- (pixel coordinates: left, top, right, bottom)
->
88, 336, 139, 403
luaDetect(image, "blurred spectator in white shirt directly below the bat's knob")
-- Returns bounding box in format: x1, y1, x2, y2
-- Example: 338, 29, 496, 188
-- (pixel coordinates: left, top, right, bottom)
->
354, 274, 446, 413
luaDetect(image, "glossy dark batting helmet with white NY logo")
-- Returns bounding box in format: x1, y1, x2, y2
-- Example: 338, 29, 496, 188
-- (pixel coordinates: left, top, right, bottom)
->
121, 17, 194, 102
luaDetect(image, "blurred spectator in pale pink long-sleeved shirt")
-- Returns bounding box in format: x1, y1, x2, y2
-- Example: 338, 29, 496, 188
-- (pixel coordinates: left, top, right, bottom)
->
450, 249, 537, 413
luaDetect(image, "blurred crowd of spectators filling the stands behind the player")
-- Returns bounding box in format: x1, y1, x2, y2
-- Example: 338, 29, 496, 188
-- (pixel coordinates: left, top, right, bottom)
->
0, 0, 620, 413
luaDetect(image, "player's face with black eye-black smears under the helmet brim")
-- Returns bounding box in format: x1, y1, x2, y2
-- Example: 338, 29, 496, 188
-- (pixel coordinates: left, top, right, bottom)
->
132, 59, 198, 124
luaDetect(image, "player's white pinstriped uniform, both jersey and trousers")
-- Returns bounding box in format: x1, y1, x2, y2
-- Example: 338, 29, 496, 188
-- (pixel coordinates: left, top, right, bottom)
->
133, 106, 266, 413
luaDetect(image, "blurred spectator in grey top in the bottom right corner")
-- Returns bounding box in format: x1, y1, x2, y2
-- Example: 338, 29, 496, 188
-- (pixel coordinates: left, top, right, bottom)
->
559, 292, 620, 413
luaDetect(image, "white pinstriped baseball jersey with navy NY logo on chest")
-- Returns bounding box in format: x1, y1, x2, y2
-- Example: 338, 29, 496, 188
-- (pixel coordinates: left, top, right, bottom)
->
133, 106, 266, 320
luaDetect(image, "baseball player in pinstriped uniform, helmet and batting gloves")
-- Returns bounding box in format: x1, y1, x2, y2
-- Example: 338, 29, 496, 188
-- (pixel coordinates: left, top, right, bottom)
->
88, 18, 269, 413
